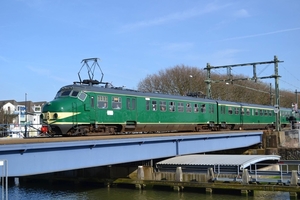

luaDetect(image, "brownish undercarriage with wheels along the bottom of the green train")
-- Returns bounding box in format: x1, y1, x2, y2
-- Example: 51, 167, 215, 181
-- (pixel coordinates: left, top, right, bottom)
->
41, 122, 285, 136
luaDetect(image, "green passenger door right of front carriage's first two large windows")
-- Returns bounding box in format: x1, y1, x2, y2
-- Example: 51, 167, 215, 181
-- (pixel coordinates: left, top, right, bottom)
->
125, 97, 137, 128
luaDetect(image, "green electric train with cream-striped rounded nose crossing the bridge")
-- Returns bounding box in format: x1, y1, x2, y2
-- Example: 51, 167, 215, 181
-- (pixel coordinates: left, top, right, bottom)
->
41, 57, 299, 136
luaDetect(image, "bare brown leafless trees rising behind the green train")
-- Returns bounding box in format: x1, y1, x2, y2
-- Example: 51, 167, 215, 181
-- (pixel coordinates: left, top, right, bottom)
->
138, 65, 295, 107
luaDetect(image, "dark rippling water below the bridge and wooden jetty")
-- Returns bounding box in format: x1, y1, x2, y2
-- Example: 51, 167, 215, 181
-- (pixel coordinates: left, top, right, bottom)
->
0, 183, 290, 200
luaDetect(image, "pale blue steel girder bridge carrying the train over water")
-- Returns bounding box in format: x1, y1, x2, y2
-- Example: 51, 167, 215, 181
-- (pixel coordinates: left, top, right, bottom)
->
0, 131, 263, 177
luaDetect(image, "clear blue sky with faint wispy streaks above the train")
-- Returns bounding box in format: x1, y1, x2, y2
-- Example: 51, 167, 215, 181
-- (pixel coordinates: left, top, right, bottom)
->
0, 0, 300, 101
